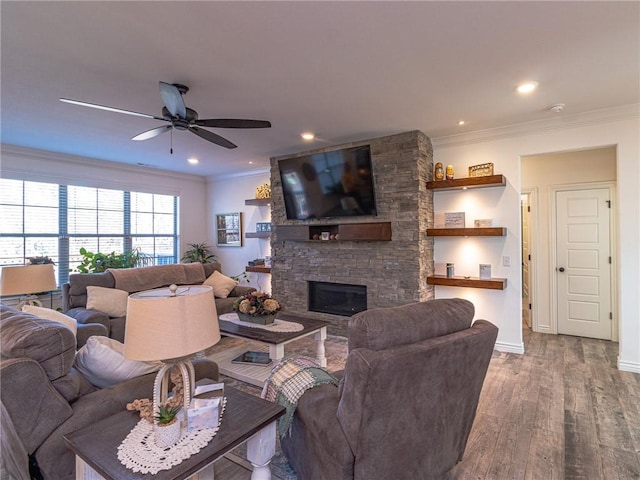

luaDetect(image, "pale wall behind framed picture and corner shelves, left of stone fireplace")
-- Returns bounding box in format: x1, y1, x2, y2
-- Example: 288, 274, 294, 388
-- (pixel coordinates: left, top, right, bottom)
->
207, 171, 271, 292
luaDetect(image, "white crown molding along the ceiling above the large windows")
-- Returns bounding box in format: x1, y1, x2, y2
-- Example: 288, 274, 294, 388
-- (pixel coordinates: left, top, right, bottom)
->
0, 143, 205, 183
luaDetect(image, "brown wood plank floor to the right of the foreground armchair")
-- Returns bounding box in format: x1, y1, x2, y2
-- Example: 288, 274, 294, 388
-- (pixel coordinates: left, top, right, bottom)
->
445, 328, 640, 480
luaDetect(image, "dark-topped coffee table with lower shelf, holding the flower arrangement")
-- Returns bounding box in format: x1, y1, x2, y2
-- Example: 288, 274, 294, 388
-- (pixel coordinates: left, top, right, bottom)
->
209, 313, 329, 387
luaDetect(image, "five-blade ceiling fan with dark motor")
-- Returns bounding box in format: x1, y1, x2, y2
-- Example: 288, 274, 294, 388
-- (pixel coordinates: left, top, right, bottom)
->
60, 82, 271, 148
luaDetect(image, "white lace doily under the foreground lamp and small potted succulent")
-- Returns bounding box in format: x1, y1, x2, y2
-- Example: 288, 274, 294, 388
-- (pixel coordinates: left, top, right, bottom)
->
118, 397, 227, 475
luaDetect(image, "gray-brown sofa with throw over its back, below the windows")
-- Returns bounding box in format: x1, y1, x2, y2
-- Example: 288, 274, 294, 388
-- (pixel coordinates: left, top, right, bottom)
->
62, 263, 255, 342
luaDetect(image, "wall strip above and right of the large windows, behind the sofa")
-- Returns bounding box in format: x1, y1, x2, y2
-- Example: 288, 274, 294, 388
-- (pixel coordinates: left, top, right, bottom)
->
0, 145, 208, 255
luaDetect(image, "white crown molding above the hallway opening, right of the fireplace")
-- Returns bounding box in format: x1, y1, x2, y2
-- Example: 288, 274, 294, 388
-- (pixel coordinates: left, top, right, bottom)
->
431, 103, 640, 148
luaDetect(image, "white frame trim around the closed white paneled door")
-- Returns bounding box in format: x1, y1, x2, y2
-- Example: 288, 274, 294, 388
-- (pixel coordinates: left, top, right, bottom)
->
549, 182, 618, 342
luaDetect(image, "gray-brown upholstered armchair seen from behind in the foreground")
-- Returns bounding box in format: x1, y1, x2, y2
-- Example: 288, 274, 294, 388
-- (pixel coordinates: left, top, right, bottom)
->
281, 299, 498, 480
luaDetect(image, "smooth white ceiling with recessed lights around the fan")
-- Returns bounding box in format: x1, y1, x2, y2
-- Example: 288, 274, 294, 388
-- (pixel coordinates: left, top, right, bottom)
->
0, 0, 640, 175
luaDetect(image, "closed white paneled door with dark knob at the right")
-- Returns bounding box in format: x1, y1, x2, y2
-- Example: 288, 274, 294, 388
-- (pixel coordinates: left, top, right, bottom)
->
555, 188, 612, 340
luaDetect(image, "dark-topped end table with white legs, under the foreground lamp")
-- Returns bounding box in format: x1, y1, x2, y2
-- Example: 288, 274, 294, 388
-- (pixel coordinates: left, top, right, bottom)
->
65, 386, 284, 480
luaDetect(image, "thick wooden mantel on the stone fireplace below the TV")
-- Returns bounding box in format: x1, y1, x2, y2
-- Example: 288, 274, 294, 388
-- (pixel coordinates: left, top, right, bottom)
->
276, 222, 391, 243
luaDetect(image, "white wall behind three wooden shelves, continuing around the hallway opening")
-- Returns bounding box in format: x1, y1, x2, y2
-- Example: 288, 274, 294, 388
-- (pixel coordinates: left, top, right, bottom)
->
427, 105, 640, 373
